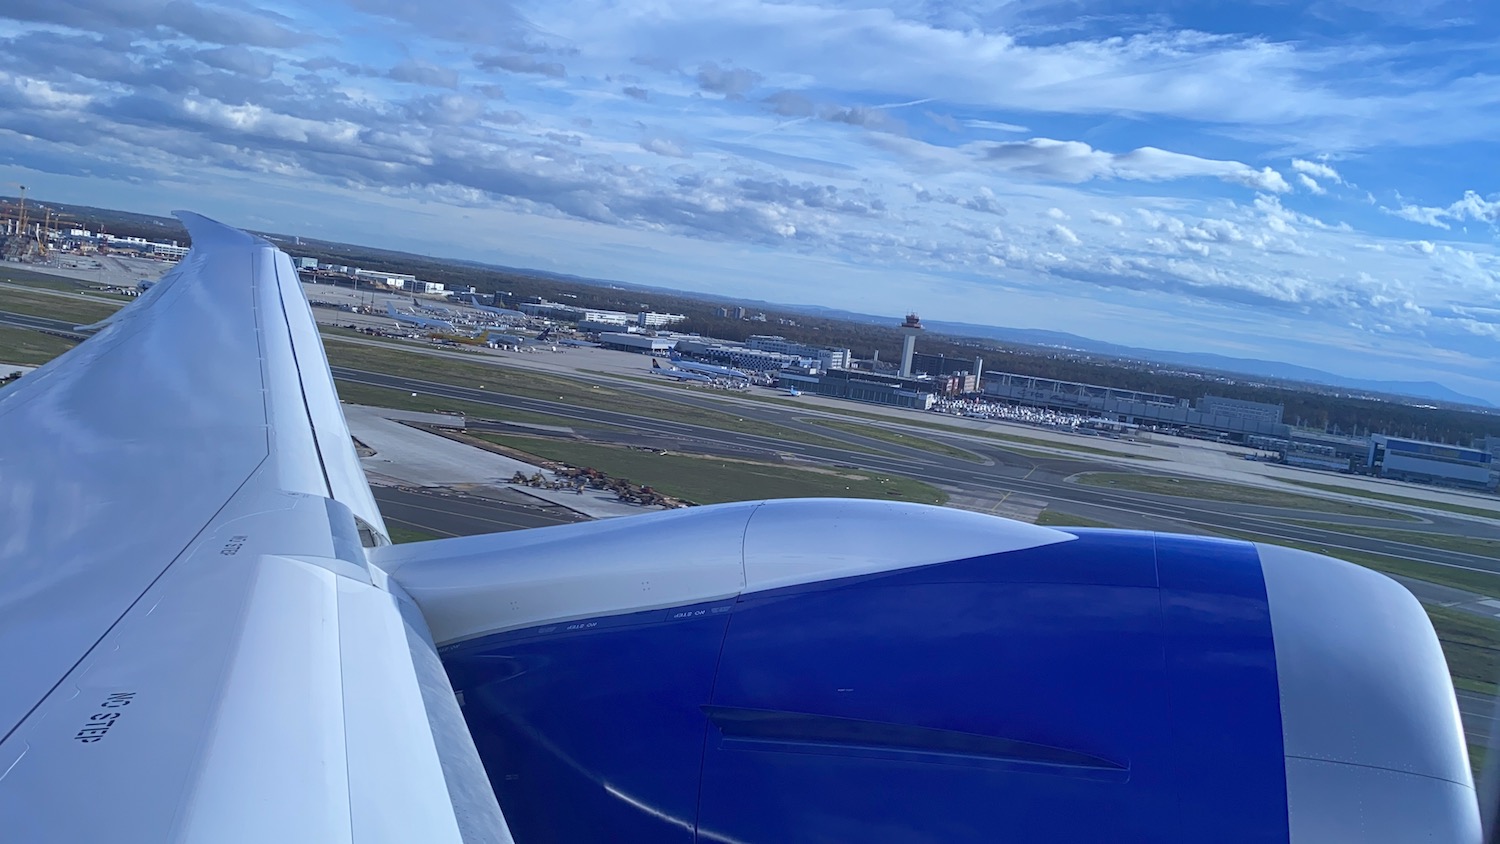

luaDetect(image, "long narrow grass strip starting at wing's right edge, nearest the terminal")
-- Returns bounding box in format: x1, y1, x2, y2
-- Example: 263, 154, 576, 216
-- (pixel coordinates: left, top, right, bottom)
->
327, 337, 875, 451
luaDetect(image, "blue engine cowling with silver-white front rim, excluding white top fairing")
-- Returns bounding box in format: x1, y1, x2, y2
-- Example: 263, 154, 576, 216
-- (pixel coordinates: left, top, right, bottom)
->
443, 531, 1476, 844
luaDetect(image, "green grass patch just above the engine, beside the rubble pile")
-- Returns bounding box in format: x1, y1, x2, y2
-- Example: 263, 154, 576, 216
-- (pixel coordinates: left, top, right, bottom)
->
477, 433, 948, 504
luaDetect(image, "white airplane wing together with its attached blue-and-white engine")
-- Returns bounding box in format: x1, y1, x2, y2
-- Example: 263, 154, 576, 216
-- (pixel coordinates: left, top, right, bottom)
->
0, 214, 1479, 844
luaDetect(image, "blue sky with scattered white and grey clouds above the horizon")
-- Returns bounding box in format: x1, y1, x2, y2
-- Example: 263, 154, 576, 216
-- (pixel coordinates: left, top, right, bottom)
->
0, 0, 1500, 403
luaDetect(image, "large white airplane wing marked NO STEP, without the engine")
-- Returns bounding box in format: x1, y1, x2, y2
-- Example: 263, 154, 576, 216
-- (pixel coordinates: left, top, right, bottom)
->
0, 214, 507, 841
